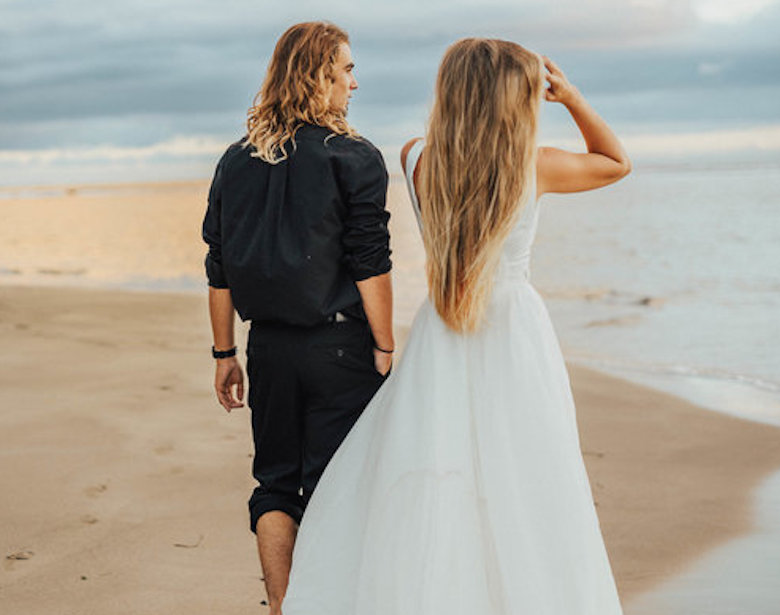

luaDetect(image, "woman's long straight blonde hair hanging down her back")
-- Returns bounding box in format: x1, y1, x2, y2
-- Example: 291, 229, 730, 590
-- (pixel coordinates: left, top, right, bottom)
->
418, 38, 543, 332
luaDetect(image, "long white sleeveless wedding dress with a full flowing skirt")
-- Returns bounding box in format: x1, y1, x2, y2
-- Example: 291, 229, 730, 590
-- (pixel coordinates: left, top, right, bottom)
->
282, 142, 621, 615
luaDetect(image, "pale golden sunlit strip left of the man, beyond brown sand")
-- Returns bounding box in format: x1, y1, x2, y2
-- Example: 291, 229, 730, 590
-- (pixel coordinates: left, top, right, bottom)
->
0, 182, 208, 285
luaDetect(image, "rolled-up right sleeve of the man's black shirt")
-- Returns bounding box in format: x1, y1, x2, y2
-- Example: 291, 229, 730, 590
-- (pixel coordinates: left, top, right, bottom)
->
341, 143, 392, 282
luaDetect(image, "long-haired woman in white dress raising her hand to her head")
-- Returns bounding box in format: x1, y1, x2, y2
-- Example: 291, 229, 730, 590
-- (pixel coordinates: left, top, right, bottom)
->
283, 39, 630, 615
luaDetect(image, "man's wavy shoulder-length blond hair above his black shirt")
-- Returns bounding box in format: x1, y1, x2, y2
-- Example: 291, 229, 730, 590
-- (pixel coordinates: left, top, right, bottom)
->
245, 21, 356, 164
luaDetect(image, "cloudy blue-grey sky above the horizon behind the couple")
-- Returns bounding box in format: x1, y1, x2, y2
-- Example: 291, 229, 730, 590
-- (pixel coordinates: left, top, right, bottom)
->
0, 0, 780, 186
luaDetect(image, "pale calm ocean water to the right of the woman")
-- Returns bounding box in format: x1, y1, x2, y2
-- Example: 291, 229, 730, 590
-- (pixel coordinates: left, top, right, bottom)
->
532, 164, 780, 425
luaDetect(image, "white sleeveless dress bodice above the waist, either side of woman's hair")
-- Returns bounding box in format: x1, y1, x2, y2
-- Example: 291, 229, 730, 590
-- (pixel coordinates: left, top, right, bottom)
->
405, 140, 539, 284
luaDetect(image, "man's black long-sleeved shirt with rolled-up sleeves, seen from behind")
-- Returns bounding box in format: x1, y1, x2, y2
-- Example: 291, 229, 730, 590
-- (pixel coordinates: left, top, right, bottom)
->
203, 124, 391, 326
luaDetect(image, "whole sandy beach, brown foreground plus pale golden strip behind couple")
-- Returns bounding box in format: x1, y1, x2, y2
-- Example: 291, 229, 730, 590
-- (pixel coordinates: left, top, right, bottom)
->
0, 182, 780, 615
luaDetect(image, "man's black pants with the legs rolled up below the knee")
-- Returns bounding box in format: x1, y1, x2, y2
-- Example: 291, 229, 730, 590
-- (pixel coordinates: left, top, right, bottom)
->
247, 320, 385, 532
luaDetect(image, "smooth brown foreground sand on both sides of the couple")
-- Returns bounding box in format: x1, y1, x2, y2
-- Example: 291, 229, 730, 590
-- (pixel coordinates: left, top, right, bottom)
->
0, 287, 780, 615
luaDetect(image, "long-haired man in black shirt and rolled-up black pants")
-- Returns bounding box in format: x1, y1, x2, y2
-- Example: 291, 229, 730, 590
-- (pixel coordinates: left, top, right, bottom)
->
203, 22, 394, 615
